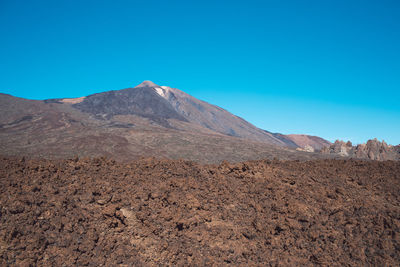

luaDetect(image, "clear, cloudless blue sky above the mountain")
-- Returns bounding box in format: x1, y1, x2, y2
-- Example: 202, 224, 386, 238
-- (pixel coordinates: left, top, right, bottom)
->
0, 0, 400, 144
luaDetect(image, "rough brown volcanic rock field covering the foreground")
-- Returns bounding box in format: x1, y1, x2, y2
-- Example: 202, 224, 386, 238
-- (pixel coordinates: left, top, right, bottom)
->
0, 158, 400, 266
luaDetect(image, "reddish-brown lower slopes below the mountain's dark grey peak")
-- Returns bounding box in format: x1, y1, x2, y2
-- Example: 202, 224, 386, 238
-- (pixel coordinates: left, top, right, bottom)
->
0, 89, 332, 163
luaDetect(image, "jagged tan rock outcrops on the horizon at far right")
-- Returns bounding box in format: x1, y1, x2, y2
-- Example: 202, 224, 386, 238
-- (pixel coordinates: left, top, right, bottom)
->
321, 139, 400, 160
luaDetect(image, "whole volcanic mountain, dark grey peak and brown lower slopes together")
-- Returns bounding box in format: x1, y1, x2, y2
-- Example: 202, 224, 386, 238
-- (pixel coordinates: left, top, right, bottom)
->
0, 81, 336, 163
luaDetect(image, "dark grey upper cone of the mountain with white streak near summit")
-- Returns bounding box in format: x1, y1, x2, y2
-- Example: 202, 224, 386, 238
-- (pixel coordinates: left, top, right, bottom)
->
73, 81, 298, 148
